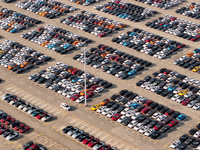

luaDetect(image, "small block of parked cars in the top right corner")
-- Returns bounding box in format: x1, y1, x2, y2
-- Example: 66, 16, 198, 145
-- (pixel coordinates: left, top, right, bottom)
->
176, 3, 200, 20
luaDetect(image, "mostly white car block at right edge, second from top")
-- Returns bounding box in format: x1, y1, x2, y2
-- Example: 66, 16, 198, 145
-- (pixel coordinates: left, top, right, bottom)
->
146, 15, 200, 42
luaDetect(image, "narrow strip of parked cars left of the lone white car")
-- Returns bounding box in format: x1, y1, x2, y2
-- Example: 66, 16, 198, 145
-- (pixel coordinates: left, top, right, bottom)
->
2, 94, 53, 122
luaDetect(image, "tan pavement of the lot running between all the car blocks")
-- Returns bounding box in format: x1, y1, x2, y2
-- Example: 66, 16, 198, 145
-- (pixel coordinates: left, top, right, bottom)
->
0, 0, 200, 150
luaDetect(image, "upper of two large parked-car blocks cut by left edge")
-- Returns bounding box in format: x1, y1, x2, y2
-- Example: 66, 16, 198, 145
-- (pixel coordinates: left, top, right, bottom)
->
0, 8, 41, 33
